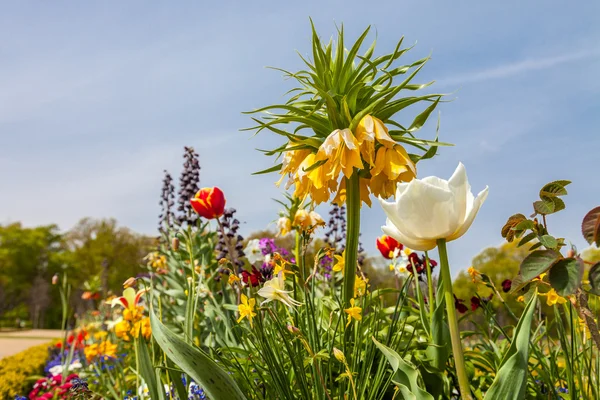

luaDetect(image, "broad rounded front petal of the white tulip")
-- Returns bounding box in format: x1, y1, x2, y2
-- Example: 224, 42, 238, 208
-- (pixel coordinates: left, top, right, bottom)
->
396, 179, 458, 239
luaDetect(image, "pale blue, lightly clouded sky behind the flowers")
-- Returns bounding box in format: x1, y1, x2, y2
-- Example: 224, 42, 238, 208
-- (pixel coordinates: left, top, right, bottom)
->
0, 0, 600, 272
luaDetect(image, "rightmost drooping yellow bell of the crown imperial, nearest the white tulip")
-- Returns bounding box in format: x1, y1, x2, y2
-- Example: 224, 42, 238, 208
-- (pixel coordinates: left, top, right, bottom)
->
369, 144, 417, 198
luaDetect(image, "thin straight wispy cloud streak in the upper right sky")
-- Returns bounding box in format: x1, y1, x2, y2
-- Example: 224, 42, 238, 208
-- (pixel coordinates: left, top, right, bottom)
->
438, 49, 600, 86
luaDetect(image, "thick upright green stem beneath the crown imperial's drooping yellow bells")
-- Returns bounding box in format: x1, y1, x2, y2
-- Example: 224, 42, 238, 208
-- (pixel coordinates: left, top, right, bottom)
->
344, 171, 360, 306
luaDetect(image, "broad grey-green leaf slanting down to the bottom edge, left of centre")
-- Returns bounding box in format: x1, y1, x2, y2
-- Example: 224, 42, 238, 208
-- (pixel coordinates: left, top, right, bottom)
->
150, 310, 246, 400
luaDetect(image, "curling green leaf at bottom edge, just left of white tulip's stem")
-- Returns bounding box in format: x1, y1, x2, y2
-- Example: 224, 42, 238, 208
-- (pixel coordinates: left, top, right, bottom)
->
372, 337, 434, 400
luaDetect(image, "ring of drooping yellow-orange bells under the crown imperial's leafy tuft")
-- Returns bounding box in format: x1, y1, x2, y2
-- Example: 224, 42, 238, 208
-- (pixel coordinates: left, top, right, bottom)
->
278, 115, 416, 205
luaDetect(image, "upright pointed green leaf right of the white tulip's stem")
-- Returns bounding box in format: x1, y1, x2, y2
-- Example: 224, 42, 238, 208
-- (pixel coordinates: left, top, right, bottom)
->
484, 295, 537, 400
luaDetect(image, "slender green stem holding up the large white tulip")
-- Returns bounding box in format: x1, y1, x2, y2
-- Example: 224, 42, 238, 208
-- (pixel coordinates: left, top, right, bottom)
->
437, 239, 472, 400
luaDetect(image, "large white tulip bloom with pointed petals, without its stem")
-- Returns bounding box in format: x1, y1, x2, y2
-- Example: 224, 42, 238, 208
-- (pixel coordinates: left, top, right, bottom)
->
379, 163, 488, 251
